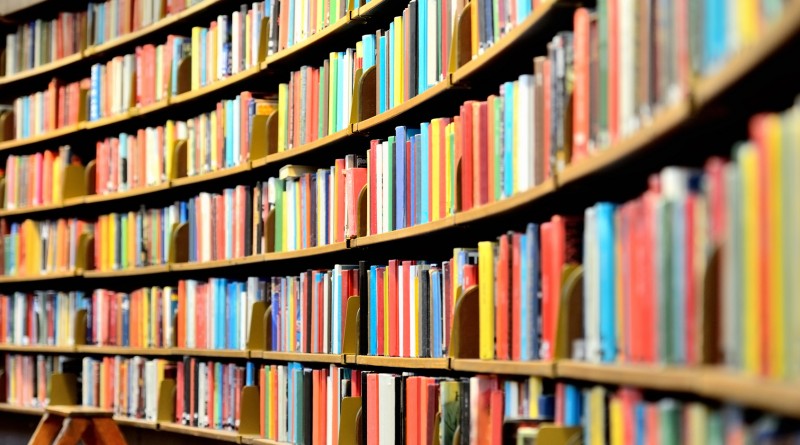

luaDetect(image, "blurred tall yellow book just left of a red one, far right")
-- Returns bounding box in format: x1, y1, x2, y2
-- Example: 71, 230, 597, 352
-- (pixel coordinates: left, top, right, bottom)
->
737, 143, 761, 374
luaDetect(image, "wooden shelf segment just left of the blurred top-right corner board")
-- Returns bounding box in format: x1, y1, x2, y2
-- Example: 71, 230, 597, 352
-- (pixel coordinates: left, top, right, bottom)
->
556, 100, 691, 186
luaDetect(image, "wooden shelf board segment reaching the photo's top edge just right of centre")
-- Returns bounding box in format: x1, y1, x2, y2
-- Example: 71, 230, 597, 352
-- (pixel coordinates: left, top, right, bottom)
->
451, 0, 565, 84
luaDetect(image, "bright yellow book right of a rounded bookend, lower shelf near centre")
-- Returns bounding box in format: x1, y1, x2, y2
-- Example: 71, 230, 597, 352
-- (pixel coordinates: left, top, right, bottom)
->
478, 241, 496, 360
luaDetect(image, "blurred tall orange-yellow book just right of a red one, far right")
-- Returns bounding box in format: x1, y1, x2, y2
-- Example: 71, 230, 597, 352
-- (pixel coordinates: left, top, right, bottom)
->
765, 114, 789, 378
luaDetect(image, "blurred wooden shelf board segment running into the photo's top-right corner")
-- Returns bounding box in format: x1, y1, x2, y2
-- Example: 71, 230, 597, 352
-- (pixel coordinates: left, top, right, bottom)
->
693, 1, 800, 105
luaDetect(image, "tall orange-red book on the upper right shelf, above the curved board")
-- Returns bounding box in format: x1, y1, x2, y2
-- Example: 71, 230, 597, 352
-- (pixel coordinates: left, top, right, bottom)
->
572, 8, 591, 160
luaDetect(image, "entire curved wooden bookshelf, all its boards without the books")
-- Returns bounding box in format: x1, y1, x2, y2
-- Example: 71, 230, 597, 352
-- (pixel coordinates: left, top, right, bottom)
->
0, 0, 800, 444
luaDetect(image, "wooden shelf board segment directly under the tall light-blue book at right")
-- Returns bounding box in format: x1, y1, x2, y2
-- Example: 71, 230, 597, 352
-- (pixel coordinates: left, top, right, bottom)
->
556, 360, 703, 393
